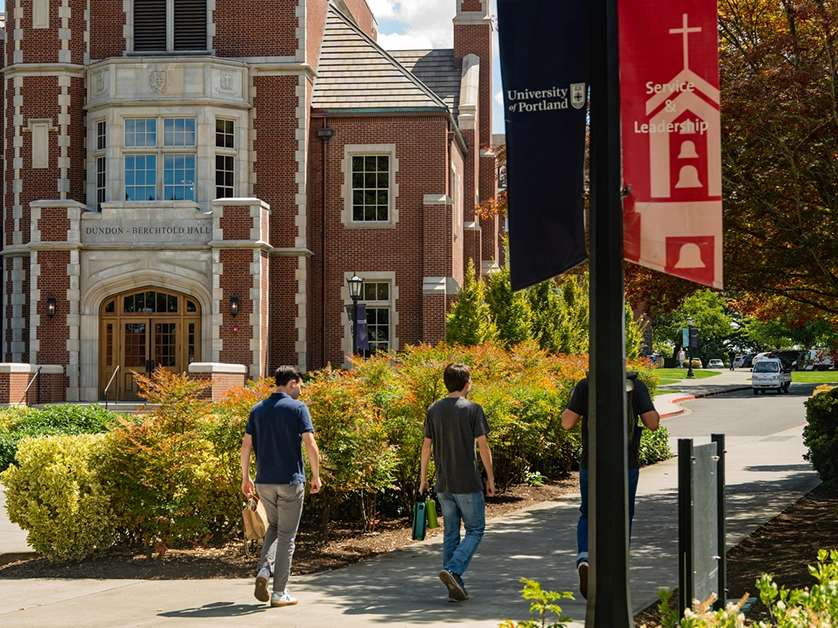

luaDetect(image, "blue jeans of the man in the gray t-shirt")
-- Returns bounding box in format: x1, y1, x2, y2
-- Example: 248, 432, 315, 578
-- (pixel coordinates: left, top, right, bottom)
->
436, 493, 486, 576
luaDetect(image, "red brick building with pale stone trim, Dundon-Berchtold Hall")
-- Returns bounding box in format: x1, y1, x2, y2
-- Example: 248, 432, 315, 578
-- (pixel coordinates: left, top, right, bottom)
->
0, 0, 501, 401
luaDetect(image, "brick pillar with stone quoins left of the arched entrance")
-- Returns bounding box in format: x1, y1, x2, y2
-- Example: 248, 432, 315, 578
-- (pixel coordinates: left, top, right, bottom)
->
29, 200, 86, 401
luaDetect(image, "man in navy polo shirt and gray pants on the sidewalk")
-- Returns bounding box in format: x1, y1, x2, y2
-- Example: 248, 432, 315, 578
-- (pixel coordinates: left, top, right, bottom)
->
241, 366, 322, 606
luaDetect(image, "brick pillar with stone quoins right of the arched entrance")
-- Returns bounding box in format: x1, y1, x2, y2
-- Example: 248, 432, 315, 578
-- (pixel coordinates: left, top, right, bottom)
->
210, 198, 271, 379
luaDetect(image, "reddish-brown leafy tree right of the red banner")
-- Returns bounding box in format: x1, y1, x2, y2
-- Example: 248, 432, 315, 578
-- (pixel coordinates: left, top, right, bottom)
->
719, 0, 838, 314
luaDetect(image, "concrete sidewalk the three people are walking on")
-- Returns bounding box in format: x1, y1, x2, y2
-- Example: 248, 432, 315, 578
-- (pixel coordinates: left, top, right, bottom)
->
0, 371, 819, 628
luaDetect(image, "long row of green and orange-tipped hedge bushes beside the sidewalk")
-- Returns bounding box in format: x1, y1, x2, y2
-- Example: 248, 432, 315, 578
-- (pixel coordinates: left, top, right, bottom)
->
0, 344, 669, 560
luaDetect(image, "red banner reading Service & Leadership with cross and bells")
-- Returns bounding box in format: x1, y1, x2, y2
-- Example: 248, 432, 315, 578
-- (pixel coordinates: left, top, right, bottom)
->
619, 0, 722, 288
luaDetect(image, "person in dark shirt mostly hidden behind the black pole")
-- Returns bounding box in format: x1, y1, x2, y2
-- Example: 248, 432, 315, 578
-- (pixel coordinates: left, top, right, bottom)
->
562, 373, 660, 598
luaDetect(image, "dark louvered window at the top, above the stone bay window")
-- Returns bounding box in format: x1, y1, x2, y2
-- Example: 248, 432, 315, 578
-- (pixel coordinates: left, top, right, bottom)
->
134, 0, 208, 52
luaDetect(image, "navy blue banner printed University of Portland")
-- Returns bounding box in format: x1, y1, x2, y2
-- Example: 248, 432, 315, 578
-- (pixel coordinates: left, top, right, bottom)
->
498, 0, 588, 290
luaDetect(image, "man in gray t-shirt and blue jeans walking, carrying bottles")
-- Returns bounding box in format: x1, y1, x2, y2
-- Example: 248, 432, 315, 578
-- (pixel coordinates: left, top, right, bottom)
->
419, 364, 495, 602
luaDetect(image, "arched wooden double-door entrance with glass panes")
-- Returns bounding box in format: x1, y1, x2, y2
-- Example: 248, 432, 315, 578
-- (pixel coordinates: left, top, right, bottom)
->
99, 287, 201, 400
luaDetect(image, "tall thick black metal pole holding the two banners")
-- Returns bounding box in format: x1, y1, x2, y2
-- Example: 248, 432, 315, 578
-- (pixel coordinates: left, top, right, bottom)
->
585, 0, 634, 628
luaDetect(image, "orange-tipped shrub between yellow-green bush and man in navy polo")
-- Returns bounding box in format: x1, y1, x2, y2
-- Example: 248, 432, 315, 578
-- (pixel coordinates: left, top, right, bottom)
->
103, 369, 228, 557
